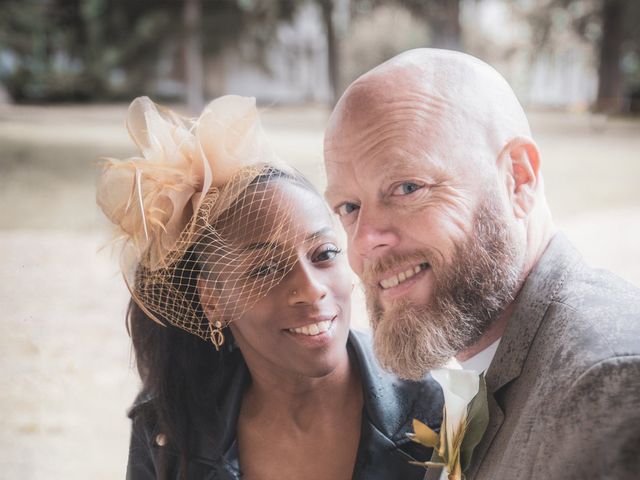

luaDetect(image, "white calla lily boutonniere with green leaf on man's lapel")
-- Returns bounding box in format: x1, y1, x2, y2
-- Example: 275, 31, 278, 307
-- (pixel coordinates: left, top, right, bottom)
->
407, 364, 489, 480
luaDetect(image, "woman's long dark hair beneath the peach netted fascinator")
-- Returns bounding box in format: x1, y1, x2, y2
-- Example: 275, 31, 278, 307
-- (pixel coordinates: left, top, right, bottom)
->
127, 167, 321, 479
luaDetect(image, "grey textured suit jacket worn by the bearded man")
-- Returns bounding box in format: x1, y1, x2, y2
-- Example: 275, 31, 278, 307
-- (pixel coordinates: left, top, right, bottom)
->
426, 234, 640, 480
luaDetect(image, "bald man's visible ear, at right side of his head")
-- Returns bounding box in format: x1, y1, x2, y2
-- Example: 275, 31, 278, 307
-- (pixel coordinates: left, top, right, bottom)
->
501, 137, 540, 218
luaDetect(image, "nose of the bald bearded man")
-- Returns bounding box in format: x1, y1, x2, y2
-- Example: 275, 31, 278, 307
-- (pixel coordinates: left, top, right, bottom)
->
349, 207, 400, 259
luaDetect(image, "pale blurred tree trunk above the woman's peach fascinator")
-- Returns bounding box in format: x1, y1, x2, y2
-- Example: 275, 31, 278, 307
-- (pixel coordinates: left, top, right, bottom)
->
183, 0, 204, 114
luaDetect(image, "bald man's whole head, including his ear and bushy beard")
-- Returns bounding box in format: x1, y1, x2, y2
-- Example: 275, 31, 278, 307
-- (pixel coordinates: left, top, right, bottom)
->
325, 49, 550, 377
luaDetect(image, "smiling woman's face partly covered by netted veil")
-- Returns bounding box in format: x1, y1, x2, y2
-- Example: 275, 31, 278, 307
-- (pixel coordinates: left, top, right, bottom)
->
205, 179, 352, 377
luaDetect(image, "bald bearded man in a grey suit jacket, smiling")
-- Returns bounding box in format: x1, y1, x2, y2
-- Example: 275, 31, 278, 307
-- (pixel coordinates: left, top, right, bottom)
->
325, 49, 640, 480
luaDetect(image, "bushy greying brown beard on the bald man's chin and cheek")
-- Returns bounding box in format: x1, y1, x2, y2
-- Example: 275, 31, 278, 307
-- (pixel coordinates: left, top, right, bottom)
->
365, 196, 522, 380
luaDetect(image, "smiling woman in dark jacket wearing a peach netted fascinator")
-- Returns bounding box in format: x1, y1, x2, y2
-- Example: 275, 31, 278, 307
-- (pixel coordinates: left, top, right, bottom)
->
98, 97, 442, 480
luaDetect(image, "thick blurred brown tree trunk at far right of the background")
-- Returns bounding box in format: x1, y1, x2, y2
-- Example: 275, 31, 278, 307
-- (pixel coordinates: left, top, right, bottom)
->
595, 0, 625, 113
